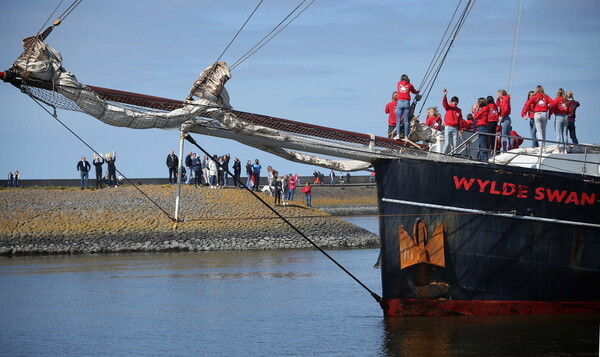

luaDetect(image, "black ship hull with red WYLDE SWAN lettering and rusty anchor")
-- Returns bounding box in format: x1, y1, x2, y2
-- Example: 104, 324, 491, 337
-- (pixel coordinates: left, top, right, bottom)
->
375, 158, 600, 316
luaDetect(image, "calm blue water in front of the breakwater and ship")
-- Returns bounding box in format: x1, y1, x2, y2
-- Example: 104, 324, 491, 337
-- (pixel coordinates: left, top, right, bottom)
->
0, 218, 599, 356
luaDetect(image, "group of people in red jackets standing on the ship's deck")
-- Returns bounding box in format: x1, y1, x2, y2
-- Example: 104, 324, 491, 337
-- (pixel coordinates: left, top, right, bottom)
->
385, 74, 579, 161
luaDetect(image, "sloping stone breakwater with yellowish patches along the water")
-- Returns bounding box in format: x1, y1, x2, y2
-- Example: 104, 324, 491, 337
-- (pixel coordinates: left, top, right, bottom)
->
0, 185, 379, 255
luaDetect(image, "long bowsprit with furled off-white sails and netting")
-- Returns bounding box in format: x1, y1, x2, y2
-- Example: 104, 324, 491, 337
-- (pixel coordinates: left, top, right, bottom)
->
4, 31, 426, 171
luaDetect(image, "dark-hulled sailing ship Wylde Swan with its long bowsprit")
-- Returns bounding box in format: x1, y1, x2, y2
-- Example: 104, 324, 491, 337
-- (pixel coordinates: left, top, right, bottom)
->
0, 1, 600, 316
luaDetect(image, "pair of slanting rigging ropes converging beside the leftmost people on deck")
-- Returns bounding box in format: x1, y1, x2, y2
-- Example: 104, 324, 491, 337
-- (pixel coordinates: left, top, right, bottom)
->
412, 0, 476, 116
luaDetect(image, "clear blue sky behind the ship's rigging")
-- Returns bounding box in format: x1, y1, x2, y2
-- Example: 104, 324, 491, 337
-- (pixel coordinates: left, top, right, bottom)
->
0, 0, 600, 179
